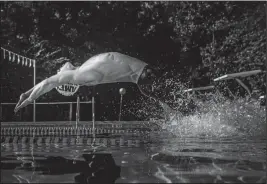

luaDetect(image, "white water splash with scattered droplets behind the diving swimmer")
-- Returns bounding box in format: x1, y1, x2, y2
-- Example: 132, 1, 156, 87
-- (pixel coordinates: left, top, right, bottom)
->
129, 79, 266, 137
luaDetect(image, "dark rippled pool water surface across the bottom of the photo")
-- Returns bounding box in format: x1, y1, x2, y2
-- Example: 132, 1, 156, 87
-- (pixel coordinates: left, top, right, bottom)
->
1, 131, 266, 183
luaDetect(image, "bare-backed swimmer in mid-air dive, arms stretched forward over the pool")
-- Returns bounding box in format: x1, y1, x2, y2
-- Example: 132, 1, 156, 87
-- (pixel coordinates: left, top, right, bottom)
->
14, 52, 173, 113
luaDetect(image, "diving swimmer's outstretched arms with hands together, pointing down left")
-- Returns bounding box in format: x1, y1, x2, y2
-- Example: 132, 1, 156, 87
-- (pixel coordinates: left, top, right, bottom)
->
14, 75, 67, 112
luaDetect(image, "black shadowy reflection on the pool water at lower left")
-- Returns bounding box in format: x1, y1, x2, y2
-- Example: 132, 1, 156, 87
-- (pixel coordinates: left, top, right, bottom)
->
1, 153, 121, 184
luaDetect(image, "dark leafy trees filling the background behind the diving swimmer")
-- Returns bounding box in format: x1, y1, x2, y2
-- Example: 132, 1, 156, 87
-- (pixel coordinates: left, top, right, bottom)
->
0, 2, 266, 121
